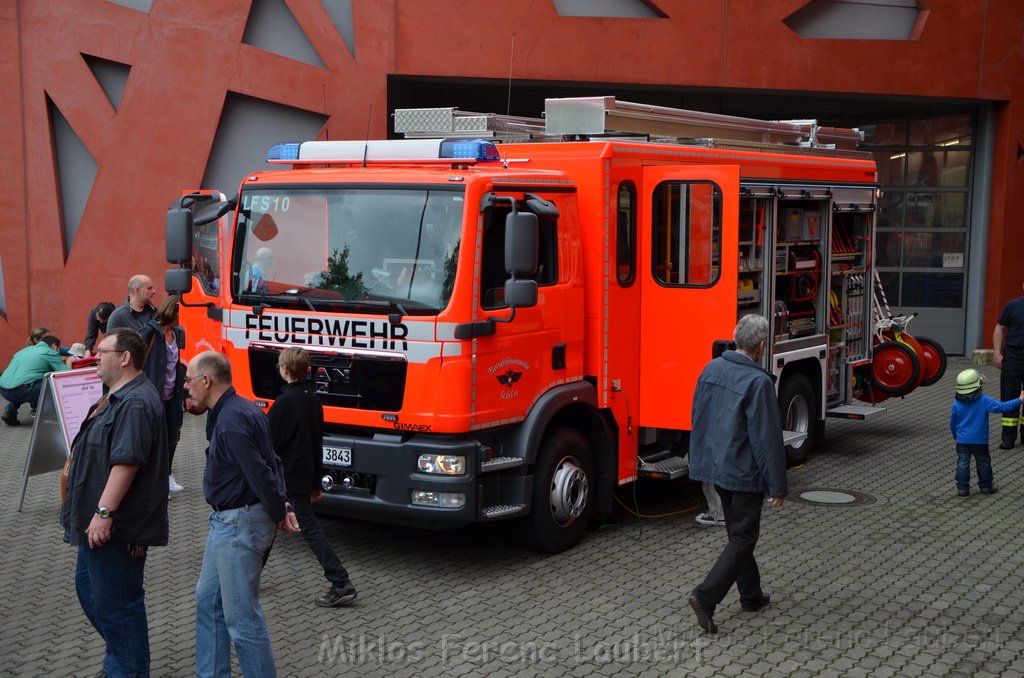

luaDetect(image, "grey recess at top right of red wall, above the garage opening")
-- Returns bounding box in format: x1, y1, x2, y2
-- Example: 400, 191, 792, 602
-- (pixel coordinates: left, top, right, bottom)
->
783, 0, 918, 40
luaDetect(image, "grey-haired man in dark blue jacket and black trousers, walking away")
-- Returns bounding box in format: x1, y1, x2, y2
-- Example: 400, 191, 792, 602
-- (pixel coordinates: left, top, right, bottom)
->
689, 314, 786, 633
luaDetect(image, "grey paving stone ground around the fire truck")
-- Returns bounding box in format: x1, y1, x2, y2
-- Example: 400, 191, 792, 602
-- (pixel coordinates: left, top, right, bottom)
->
0, 359, 1024, 677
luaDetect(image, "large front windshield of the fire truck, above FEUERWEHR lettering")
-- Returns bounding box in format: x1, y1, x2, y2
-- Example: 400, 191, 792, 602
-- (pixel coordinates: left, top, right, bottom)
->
232, 186, 464, 314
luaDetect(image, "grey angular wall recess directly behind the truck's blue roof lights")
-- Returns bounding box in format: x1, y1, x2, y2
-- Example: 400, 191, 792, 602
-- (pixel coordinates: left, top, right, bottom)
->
194, 92, 328, 198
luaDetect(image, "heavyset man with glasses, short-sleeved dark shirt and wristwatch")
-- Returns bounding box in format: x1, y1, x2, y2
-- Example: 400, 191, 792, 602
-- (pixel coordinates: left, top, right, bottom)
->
60, 328, 169, 676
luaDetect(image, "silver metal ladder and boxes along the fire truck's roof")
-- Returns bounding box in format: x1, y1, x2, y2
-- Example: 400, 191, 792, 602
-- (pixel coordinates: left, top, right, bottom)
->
394, 96, 863, 152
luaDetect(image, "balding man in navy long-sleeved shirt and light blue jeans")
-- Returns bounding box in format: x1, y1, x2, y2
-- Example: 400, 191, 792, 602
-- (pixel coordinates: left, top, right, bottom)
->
185, 351, 299, 678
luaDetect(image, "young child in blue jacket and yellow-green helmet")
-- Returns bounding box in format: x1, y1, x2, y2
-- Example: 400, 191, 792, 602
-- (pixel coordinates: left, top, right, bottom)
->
949, 369, 1024, 497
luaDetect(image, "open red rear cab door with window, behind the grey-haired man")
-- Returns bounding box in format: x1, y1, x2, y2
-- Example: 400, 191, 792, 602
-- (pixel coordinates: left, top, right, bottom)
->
638, 166, 739, 429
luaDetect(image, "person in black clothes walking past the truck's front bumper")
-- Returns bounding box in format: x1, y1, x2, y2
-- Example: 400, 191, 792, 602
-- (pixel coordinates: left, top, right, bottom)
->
267, 348, 355, 607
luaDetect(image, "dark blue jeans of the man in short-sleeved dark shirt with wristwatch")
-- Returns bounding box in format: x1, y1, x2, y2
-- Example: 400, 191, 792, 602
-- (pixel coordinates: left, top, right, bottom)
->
75, 544, 150, 678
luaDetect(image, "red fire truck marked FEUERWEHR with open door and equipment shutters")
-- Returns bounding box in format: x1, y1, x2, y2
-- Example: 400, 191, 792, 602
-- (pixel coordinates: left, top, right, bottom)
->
166, 97, 941, 551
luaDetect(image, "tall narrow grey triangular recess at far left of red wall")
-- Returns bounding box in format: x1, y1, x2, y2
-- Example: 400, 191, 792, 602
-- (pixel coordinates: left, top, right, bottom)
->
46, 97, 97, 262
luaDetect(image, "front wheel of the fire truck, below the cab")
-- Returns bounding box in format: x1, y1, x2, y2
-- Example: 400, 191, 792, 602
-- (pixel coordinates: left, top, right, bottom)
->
520, 428, 594, 553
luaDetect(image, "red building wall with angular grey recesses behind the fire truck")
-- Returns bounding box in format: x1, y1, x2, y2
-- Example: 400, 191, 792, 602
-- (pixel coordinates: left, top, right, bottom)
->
0, 0, 1024, 359
